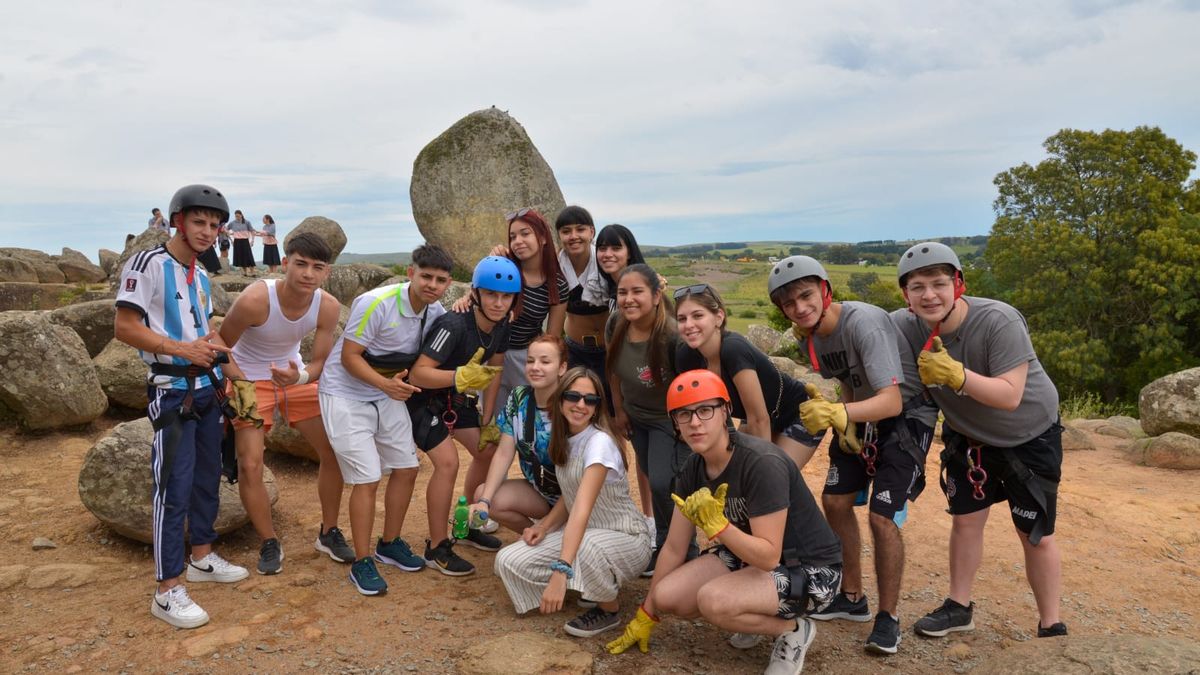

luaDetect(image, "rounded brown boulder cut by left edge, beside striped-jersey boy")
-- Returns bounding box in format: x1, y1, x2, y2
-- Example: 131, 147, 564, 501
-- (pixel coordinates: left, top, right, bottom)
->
0, 312, 108, 430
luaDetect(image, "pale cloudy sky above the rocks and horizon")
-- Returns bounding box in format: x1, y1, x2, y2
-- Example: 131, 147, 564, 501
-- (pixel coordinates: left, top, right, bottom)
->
0, 0, 1200, 259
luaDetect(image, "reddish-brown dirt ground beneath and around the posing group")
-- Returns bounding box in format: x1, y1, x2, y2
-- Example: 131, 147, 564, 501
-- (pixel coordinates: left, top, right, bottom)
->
0, 418, 1200, 674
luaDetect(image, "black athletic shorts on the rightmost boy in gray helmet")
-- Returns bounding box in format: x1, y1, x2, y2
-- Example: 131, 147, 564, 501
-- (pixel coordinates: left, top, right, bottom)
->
942, 422, 1062, 536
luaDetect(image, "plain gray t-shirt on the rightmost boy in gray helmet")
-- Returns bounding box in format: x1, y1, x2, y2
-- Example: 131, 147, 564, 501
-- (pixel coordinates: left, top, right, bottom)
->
892, 295, 1058, 448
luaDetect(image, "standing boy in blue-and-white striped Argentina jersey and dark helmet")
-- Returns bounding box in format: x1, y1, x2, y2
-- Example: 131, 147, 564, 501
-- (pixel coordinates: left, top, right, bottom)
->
114, 185, 248, 628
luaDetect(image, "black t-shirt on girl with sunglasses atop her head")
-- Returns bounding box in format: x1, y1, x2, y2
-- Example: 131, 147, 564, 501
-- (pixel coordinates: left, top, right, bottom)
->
676, 333, 808, 434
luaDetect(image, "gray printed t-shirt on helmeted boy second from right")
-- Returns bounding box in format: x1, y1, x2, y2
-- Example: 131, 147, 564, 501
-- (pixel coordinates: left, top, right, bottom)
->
800, 301, 937, 426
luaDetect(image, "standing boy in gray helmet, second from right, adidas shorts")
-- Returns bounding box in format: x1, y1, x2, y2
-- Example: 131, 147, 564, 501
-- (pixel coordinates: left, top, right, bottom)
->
768, 256, 937, 655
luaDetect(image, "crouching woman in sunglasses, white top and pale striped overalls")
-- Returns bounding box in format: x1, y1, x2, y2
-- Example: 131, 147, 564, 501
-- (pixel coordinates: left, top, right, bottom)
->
496, 368, 650, 638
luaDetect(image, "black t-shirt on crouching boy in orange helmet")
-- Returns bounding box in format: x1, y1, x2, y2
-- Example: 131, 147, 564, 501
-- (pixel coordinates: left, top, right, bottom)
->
676, 432, 841, 567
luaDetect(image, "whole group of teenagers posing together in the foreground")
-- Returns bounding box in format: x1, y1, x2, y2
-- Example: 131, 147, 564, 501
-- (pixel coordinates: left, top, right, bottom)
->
116, 185, 1067, 674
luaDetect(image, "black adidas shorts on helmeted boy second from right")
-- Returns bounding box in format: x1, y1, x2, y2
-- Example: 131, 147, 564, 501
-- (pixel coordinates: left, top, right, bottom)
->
823, 417, 934, 527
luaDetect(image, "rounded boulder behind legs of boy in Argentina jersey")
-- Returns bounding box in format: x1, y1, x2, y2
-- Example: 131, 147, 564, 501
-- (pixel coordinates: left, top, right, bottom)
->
79, 417, 278, 543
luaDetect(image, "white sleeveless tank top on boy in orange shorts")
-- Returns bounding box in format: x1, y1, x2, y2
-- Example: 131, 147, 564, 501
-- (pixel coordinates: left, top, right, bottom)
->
233, 279, 322, 381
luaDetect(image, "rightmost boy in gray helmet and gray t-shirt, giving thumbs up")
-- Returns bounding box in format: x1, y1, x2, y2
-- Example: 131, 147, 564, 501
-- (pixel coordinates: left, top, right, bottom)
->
892, 241, 1067, 638
